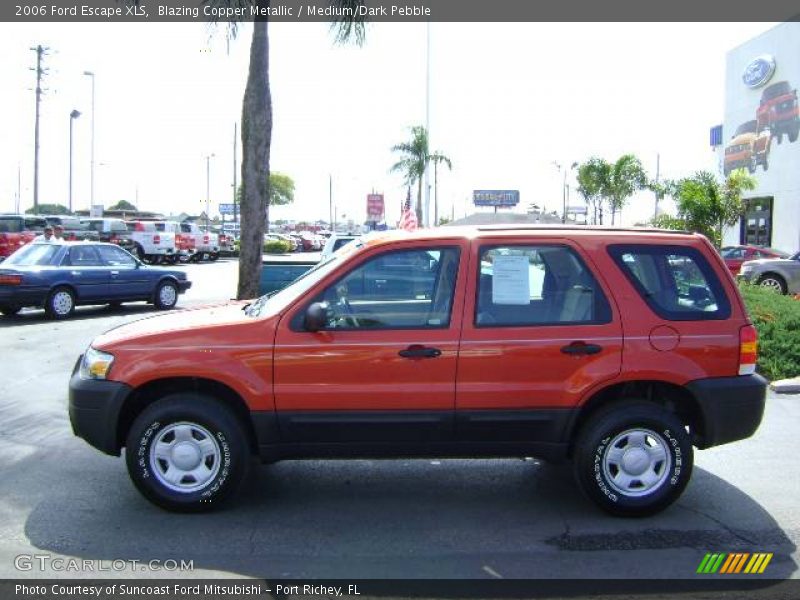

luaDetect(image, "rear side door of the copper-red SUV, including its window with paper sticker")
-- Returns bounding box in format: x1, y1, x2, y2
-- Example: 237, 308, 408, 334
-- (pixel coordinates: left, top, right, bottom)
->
456, 236, 622, 443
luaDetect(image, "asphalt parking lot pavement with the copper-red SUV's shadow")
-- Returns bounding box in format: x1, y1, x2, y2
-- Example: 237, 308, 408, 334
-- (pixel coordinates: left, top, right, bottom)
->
0, 259, 800, 580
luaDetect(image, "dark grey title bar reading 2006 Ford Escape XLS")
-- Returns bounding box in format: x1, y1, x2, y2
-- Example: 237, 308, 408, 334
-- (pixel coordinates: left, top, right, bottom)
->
0, 0, 800, 23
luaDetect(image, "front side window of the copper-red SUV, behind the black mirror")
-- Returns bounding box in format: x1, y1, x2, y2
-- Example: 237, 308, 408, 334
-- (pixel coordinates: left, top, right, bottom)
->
308, 247, 459, 330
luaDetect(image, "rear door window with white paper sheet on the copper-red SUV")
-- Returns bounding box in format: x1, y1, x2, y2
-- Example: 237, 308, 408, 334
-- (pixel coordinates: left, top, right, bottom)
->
475, 246, 611, 327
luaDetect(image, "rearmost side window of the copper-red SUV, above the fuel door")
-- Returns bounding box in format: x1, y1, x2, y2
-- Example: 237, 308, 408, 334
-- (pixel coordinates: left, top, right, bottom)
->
609, 245, 731, 321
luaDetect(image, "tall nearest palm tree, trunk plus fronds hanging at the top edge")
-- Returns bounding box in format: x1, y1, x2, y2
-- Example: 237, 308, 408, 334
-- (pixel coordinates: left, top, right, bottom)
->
208, 0, 364, 299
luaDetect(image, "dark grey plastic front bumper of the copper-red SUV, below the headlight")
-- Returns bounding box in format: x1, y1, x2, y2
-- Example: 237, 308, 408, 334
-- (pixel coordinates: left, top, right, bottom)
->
69, 357, 131, 456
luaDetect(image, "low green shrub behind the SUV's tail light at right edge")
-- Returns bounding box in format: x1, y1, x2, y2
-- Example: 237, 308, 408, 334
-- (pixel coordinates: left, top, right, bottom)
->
740, 284, 800, 379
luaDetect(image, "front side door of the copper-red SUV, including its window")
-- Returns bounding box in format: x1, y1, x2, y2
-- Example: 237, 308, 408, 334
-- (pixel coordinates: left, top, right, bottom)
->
274, 241, 468, 443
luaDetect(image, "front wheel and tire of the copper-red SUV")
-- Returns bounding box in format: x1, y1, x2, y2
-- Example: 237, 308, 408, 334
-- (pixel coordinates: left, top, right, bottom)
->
125, 393, 251, 512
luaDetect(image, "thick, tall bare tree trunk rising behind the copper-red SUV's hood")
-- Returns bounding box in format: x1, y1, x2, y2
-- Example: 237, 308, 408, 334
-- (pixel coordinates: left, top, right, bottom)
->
236, 17, 272, 300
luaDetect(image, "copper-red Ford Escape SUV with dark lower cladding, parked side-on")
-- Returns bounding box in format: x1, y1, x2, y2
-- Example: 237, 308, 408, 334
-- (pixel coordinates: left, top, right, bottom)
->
69, 227, 766, 515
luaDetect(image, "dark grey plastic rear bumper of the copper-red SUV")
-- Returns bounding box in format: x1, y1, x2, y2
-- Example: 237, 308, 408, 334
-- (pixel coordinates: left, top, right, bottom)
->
686, 374, 767, 449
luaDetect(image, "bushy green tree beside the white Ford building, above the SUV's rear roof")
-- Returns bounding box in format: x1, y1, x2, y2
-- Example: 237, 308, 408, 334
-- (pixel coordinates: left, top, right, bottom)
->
653, 169, 756, 248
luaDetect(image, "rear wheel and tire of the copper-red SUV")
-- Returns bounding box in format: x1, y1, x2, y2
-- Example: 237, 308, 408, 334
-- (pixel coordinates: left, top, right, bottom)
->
573, 401, 693, 517
